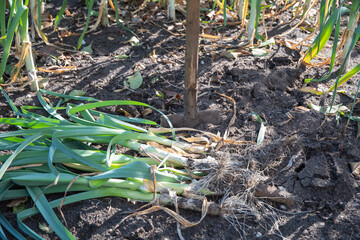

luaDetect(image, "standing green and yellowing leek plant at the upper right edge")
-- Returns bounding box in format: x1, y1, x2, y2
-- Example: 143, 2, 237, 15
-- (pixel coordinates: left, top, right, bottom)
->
300, 0, 360, 126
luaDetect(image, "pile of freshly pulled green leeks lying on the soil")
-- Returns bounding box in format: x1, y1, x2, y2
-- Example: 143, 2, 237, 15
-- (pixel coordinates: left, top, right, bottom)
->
0, 90, 221, 239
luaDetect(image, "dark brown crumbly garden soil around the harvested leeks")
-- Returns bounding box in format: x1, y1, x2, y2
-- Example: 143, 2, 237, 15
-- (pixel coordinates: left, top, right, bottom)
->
0, 1, 360, 240
